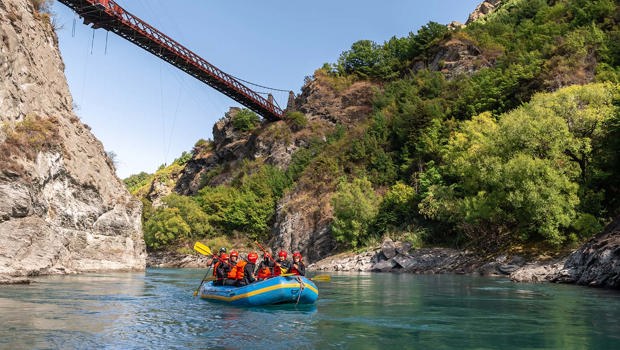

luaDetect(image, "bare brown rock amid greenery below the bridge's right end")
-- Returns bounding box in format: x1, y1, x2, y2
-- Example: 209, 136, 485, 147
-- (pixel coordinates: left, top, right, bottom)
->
175, 74, 377, 262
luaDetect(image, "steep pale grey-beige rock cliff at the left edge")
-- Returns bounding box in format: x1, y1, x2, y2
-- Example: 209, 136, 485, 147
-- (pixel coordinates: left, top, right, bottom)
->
0, 0, 146, 276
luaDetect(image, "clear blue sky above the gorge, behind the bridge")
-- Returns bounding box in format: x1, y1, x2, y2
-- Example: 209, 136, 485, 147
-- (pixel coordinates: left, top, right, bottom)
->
52, 0, 481, 178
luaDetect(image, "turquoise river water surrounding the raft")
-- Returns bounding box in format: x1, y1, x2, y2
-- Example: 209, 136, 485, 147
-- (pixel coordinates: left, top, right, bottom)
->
0, 269, 620, 349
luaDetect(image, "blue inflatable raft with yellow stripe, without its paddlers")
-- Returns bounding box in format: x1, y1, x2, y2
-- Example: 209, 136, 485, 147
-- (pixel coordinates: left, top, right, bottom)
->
200, 276, 319, 306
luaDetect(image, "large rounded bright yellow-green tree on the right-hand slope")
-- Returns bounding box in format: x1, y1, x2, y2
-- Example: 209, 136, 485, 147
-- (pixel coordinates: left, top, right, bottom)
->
420, 98, 579, 244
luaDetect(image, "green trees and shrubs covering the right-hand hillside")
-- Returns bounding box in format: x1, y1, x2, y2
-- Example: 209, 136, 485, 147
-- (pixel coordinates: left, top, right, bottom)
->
127, 0, 620, 258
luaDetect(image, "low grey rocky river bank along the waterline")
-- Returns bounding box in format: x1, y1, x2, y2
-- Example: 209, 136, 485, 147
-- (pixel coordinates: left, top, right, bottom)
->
7, 218, 620, 289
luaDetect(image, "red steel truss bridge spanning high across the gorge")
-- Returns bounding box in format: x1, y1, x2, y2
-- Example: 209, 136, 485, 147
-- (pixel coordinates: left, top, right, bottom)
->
58, 0, 283, 121
